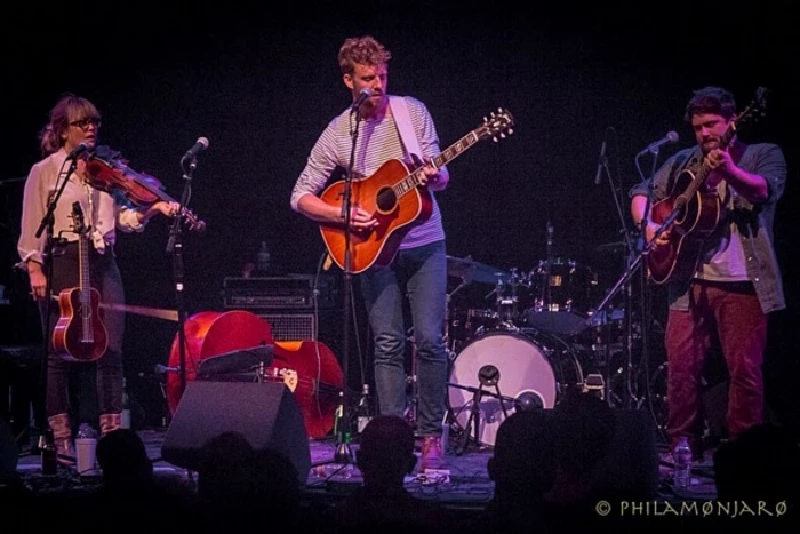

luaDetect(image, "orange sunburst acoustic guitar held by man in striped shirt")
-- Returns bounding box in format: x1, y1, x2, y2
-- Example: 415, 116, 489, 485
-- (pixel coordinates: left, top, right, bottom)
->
320, 108, 514, 274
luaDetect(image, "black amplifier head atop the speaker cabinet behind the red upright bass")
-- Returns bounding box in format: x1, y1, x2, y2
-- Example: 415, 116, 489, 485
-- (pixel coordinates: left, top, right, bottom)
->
223, 275, 333, 310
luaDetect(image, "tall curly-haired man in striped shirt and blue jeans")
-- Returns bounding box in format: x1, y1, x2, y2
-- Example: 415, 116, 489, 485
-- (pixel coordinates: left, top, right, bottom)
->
291, 36, 449, 470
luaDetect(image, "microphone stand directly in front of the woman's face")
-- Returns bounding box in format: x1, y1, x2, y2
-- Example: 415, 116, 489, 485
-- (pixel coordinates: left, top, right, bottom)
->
34, 157, 78, 448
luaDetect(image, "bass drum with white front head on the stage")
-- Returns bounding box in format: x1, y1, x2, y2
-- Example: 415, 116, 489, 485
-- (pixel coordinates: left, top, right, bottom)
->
448, 331, 583, 446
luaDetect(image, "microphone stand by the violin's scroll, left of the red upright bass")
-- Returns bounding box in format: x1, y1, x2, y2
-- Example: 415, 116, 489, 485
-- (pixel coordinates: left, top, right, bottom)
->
167, 156, 197, 402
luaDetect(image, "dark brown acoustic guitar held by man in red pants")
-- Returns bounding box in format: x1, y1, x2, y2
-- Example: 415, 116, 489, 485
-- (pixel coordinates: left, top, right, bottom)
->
647, 87, 767, 285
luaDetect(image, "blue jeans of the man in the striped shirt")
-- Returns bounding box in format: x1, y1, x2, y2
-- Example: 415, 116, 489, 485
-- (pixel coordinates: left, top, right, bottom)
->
361, 241, 448, 436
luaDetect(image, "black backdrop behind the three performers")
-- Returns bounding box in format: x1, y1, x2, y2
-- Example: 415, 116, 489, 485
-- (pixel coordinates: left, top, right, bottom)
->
0, 2, 798, 432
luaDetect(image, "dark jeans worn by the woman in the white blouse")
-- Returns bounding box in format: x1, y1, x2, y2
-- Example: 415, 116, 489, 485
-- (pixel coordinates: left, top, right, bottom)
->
39, 243, 125, 419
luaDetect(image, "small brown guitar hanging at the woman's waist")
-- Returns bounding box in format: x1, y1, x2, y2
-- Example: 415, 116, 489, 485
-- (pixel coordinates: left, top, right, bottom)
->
53, 201, 108, 362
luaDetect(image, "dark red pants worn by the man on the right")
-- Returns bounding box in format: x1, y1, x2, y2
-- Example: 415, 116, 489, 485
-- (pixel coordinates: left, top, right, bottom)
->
665, 280, 767, 458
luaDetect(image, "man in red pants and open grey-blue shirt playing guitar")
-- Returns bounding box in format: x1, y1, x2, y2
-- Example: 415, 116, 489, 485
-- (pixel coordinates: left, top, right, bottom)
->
630, 87, 786, 460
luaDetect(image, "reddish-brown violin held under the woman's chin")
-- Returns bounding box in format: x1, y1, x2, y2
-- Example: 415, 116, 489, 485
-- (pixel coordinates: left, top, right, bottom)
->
85, 145, 206, 232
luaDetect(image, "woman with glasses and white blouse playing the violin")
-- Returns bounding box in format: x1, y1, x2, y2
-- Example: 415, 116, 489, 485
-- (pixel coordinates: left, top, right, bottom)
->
17, 94, 179, 456
